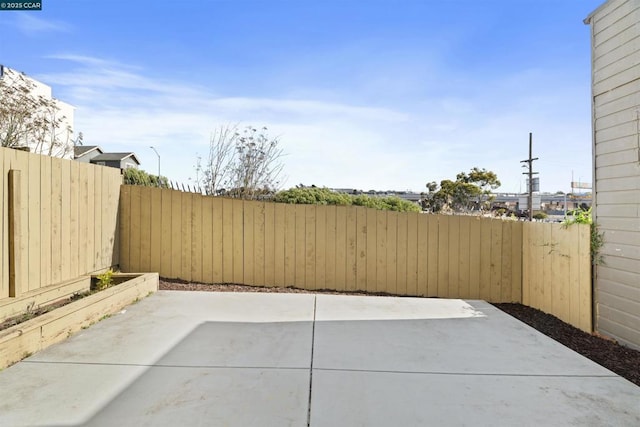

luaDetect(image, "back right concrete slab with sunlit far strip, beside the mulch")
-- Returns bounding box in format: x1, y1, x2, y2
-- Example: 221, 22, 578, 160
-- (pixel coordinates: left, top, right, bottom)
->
313, 295, 612, 376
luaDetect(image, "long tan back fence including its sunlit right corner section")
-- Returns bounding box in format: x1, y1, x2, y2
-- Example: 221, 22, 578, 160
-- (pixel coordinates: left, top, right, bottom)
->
120, 186, 591, 331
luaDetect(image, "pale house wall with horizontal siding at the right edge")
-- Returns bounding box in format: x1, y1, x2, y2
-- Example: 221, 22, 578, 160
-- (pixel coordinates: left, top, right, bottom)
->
585, 0, 640, 348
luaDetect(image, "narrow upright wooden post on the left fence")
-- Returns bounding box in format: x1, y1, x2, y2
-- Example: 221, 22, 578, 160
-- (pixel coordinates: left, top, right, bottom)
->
9, 169, 23, 298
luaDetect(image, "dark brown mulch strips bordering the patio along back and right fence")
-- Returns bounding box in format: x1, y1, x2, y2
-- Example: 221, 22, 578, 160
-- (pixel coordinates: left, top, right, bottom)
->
160, 279, 640, 386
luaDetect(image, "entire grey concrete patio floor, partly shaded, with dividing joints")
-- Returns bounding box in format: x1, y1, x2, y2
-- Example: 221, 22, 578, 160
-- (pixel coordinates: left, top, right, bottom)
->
0, 291, 640, 427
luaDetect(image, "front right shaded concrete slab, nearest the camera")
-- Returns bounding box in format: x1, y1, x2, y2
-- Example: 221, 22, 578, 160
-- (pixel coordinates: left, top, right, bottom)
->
311, 370, 640, 427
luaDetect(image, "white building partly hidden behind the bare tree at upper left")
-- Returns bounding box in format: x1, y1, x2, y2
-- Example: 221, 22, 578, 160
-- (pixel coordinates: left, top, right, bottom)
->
0, 65, 74, 159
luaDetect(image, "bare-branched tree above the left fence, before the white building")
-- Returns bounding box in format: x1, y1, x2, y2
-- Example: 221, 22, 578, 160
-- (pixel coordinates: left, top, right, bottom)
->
0, 68, 73, 157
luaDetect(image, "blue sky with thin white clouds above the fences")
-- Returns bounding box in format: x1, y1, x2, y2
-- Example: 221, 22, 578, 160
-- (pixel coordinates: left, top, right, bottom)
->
0, 0, 603, 192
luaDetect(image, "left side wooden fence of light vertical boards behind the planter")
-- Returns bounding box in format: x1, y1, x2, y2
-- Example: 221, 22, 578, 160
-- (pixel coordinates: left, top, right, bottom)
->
0, 148, 122, 300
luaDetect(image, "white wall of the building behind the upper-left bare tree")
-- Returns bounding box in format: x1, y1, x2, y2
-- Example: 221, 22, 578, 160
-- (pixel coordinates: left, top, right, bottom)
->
0, 66, 74, 159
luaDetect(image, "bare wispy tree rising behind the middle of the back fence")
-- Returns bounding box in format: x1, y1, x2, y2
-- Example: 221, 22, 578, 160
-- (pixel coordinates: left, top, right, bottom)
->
196, 125, 283, 199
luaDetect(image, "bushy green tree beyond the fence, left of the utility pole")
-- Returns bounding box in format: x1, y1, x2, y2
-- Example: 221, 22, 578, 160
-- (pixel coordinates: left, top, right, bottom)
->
422, 167, 501, 212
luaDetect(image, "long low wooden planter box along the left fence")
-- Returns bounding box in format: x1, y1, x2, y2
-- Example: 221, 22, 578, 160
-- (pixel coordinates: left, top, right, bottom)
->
0, 273, 158, 369
